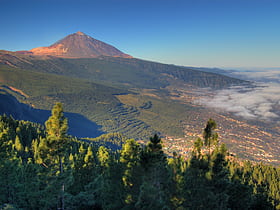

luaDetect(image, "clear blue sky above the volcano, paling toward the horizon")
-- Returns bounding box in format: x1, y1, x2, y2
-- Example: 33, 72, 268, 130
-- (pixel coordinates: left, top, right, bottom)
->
0, 0, 280, 68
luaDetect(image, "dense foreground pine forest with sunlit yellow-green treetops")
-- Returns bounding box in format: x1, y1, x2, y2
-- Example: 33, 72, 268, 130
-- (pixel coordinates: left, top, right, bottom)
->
0, 103, 280, 210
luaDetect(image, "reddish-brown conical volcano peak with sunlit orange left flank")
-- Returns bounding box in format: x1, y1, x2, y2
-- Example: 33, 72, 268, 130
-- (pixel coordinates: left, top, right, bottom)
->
28, 31, 132, 58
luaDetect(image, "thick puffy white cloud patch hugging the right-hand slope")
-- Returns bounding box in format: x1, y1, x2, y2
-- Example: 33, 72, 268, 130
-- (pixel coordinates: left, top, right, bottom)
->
197, 83, 280, 120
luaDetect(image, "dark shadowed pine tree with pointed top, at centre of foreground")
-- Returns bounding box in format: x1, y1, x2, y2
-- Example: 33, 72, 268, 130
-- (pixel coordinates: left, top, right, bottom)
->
135, 134, 172, 209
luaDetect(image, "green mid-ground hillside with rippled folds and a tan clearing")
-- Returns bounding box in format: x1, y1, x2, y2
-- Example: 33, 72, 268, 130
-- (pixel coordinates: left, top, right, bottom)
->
0, 63, 219, 139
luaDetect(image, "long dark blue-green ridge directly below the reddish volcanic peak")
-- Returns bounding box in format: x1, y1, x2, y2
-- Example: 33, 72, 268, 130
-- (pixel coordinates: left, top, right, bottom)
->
0, 51, 247, 89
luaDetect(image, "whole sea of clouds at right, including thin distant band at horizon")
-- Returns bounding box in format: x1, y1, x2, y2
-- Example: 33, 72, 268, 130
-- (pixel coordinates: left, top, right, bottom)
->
198, 69, 280, 120
